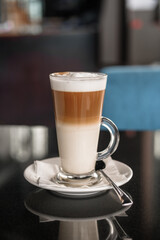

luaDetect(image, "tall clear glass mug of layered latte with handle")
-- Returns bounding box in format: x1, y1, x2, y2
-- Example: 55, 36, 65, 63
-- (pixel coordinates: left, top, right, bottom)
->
50, 72, 119, 187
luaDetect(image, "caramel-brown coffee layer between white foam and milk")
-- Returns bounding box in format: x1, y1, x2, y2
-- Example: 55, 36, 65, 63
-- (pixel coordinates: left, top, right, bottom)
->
53, 90, 105, 124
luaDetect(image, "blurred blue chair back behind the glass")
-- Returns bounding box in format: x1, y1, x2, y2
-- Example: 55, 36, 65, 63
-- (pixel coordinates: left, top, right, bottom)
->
100, 65, 160, 130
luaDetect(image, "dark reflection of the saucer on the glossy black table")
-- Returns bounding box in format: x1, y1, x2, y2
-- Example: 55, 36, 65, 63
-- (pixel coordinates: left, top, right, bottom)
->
25, 189, 130, 221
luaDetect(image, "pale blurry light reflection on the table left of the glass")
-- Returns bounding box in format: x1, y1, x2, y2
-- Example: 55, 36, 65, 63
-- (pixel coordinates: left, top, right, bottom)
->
0, 126, 48, 162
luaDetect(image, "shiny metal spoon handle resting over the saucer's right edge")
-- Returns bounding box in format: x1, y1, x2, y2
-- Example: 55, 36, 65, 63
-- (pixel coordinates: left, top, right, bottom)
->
99, 170, 133, 206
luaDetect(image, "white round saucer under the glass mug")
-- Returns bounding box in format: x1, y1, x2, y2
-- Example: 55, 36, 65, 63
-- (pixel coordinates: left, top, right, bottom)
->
24, 158, 133, 197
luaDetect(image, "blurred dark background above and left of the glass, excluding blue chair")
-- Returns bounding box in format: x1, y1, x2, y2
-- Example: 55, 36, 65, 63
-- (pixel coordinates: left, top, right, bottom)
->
0, 0, 160, 125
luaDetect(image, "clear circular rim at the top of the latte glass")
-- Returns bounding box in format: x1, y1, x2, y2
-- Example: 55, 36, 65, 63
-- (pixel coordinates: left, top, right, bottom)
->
49, 71, 108, 82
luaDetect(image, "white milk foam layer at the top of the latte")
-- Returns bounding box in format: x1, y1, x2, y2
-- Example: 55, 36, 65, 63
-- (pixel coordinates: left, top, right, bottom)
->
49, 72, 107, 92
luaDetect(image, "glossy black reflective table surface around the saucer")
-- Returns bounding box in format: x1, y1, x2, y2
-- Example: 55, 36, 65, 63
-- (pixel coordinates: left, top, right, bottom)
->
0, 126, 160, 240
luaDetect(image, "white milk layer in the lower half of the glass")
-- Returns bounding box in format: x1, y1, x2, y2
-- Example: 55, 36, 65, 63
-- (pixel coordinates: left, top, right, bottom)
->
56, 123, 100, 174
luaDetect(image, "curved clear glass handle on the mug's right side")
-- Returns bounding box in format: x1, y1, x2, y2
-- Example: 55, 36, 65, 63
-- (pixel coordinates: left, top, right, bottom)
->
97, 117, 120, 160
